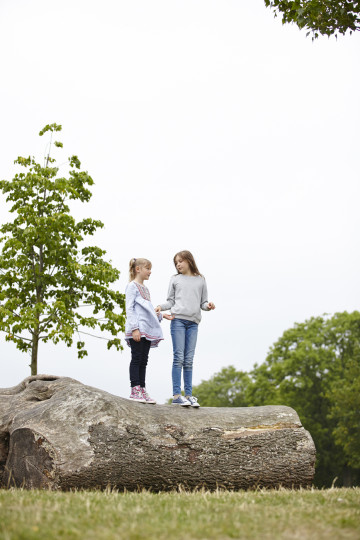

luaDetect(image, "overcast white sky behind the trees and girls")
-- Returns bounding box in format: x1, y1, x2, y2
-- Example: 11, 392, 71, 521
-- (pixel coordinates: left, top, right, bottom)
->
0, 0, 360, 402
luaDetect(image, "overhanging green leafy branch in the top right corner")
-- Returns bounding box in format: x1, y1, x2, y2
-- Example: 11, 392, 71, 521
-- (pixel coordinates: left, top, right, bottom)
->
265, 0, 360, 39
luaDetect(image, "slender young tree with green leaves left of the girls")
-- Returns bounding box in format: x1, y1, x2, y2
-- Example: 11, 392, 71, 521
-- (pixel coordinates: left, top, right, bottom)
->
0, 124, 125, 375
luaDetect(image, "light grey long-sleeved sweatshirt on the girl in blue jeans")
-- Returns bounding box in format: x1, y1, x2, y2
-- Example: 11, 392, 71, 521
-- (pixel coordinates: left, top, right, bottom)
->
160, 274, 210, 324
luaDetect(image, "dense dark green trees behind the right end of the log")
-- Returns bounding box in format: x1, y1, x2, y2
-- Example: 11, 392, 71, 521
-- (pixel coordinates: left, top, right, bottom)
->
193, 311, 360, 487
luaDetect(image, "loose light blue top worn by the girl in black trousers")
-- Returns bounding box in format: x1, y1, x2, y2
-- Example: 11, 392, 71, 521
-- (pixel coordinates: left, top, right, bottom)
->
125, 281, 164, 347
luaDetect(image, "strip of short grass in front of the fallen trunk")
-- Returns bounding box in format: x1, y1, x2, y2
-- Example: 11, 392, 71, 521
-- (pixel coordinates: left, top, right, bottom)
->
0, 488, 360, 540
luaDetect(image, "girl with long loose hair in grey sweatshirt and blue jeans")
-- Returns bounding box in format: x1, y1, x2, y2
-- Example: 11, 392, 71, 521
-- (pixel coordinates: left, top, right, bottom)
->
155, 251, 215, 407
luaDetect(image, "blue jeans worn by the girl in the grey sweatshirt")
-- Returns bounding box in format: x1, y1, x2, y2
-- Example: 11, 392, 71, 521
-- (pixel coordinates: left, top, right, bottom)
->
170, 319, 198, 396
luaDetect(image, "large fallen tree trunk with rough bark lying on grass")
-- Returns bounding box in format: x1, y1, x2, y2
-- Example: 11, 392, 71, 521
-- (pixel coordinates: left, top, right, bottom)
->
0, 375, 315, 490
